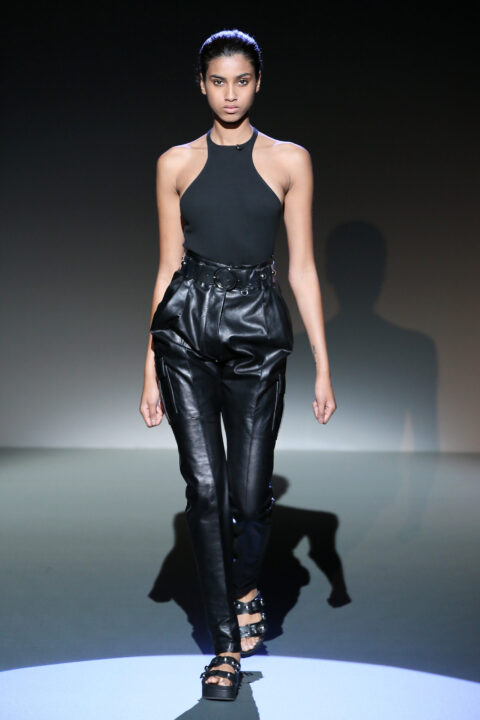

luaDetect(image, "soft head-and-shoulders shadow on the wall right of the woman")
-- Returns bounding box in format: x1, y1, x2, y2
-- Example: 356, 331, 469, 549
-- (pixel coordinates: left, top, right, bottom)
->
284, 222, 438, 452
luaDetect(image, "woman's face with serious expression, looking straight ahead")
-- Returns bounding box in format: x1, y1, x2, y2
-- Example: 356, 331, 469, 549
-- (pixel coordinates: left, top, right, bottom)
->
200, 53, 261, 122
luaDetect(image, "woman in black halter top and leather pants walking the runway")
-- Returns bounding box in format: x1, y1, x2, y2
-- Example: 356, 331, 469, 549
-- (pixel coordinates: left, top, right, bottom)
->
140, 29, 336, 700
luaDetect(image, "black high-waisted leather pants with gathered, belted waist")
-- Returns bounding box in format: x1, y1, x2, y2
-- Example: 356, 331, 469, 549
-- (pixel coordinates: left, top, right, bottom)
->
150, 250, 293, 654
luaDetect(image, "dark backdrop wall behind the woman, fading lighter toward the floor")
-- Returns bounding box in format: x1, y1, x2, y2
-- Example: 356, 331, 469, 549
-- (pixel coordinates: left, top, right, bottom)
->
1, 2, 480, 451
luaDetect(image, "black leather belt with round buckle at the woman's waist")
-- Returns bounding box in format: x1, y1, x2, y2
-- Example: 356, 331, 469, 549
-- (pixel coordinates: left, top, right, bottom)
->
180, 255, 276, 294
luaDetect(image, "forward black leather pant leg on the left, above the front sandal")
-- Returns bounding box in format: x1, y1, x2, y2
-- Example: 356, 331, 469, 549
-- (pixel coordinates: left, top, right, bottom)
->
155, 337, 241, 653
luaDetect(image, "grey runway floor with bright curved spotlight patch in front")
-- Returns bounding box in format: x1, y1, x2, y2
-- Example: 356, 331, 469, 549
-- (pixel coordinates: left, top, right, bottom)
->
0, 449, 480, 720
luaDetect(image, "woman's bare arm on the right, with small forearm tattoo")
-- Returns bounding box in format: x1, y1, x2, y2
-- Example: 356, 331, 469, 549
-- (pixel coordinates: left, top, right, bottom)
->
284, 143, 337, 423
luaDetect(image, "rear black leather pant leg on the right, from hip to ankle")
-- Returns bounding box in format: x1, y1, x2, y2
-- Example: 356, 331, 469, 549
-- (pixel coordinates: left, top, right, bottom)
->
220, 278, 293, 598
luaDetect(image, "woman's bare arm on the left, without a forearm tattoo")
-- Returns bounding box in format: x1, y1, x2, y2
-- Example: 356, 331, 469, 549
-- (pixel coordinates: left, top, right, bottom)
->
140, 147, 184, 427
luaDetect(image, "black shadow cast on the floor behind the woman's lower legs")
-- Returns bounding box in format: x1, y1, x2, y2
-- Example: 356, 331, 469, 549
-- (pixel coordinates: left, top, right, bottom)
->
148, 475, 351, 654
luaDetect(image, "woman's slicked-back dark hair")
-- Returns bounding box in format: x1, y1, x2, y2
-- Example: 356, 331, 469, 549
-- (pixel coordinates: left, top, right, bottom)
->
195, 28, 263, 85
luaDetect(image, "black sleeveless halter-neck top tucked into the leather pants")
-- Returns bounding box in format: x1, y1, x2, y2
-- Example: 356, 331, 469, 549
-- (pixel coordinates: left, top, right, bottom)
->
180, 128, 283, 265
